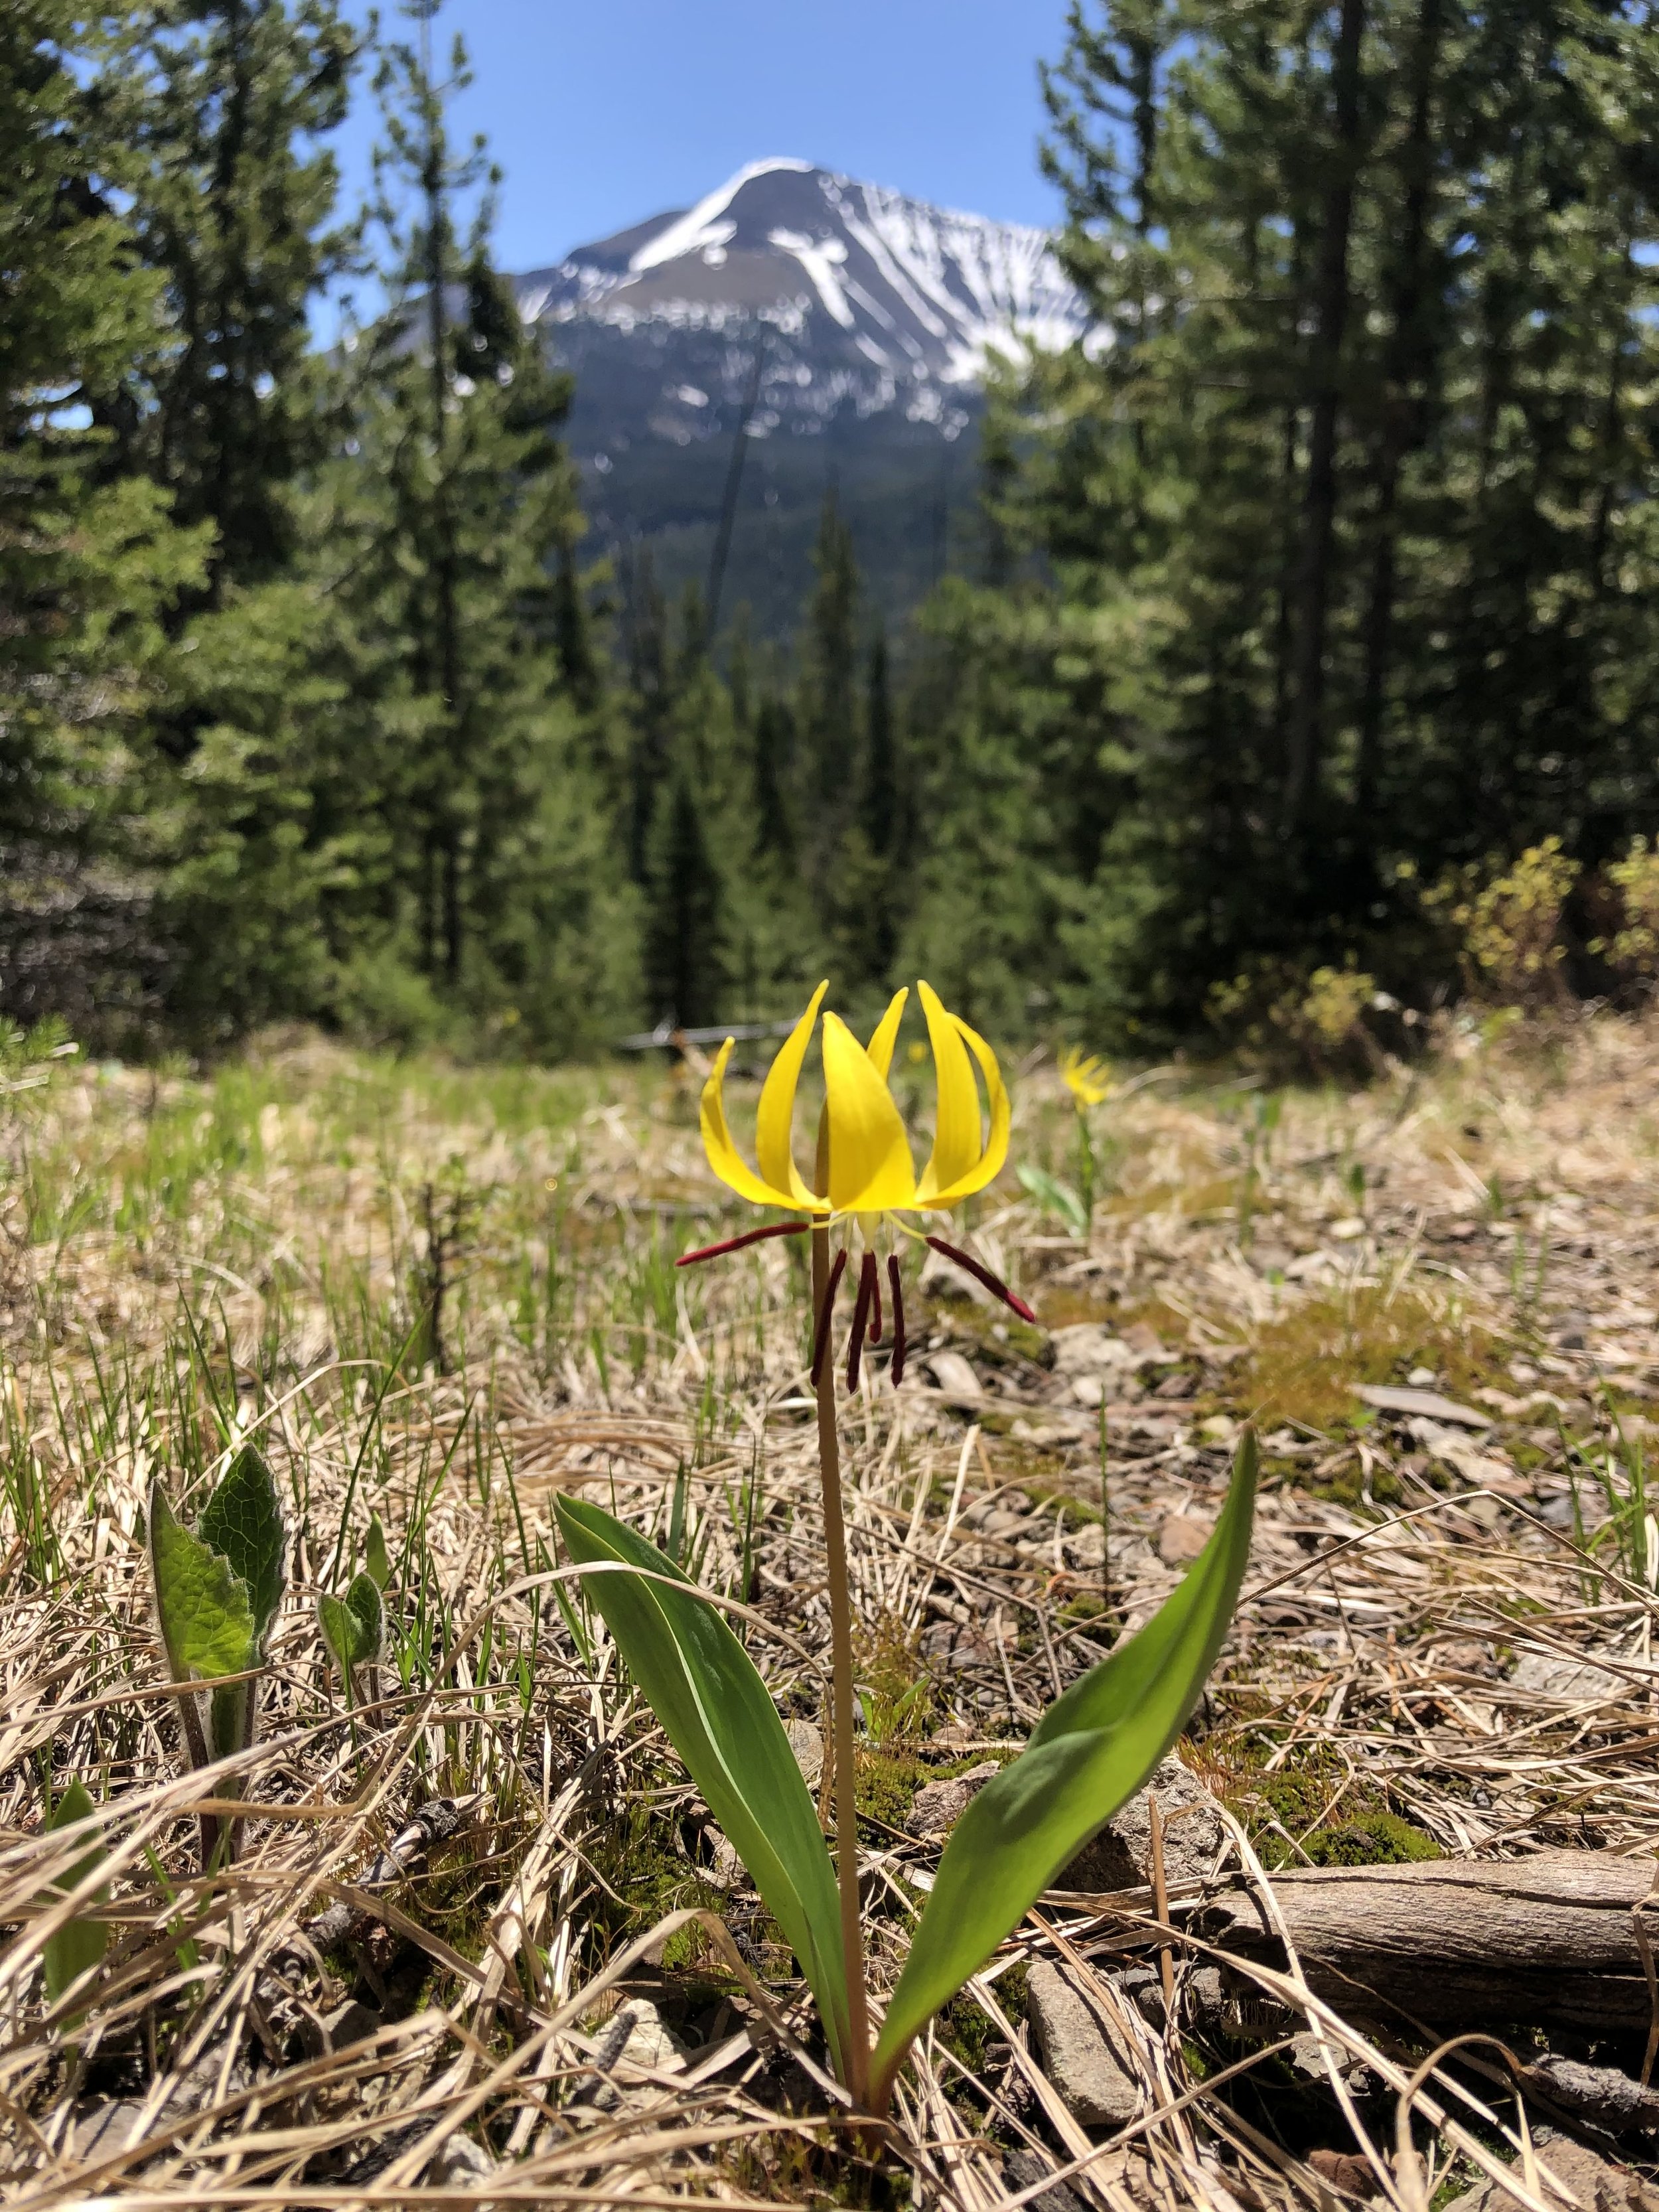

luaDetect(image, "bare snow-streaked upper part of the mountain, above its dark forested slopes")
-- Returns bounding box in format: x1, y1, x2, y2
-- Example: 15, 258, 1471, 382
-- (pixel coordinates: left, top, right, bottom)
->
518, 159, 1086, 440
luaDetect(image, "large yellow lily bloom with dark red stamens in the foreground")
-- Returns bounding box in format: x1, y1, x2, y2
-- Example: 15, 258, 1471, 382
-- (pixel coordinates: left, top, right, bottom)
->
679, 982, 1033, 1380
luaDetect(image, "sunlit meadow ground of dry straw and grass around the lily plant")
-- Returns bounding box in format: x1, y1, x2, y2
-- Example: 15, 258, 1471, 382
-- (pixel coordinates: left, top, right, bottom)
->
0, 1020, 1659, 2205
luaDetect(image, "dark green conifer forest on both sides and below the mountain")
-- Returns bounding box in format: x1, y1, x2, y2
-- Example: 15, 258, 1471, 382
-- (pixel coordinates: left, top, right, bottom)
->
0, 0, 1659, 1057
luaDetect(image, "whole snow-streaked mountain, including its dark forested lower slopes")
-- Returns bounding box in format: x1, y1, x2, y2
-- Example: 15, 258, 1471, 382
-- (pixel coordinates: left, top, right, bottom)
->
513, 161, 1086, 637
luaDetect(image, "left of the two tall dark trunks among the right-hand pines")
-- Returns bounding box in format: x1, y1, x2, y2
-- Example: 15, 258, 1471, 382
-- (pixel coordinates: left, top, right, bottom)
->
1283, 0, 1365, 836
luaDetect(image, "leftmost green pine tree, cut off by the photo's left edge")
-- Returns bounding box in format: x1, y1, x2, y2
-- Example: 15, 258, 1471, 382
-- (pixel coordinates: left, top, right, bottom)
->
0, 0, 206, 1042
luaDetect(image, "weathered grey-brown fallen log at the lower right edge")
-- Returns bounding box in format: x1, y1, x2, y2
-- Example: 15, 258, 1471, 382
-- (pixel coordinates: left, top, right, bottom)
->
1188, 1852, 1659, 2035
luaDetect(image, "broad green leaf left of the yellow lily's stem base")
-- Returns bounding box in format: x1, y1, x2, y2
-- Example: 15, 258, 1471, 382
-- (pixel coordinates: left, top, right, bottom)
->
553, 1497, 847, 2079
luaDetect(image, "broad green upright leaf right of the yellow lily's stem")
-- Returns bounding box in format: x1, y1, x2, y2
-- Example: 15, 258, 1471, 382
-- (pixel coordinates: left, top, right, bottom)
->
874, 1431, 1256, 2099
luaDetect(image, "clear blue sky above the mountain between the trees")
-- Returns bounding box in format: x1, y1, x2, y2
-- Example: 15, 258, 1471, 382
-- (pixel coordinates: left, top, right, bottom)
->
336, 0, 1079, 270
